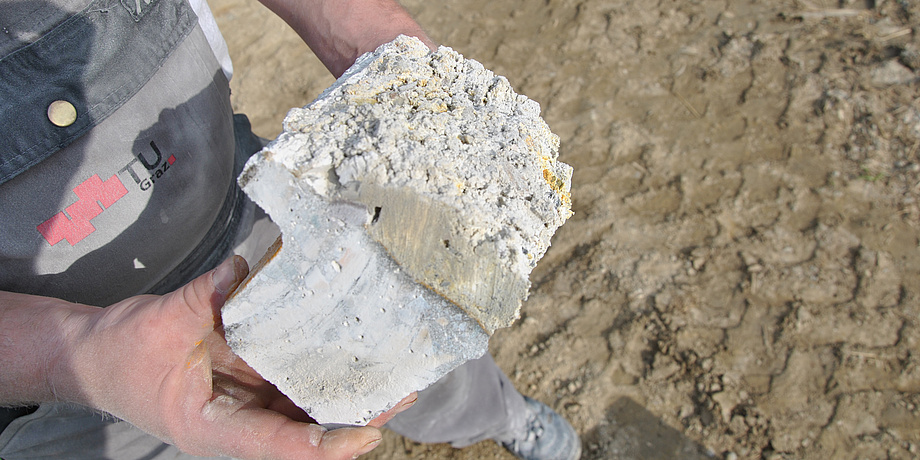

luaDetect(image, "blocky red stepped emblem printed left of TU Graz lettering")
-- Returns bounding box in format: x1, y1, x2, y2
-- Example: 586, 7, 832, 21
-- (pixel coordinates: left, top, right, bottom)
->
37, 174, 128, 246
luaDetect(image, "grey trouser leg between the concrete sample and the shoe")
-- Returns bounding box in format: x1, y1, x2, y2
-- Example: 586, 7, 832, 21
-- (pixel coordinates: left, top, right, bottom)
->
386, 353, 526, 447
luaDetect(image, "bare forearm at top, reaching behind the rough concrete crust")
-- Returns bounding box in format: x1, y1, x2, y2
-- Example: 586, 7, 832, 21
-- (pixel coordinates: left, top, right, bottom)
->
260, 0, 436, 78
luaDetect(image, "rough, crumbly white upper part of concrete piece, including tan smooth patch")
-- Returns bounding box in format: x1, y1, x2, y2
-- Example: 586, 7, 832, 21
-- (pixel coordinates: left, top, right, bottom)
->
267, 36, 572, 333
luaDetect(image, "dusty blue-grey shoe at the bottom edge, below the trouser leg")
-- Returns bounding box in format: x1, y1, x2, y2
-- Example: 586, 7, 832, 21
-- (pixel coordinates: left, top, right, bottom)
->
494, 396, 581, 460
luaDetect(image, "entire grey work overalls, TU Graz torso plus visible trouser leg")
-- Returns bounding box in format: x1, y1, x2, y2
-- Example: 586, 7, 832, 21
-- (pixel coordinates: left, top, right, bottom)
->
0, 0, 523, 454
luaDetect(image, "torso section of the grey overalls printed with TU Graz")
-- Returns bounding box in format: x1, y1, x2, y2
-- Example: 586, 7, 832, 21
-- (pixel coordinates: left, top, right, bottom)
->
0, 0, 260, 306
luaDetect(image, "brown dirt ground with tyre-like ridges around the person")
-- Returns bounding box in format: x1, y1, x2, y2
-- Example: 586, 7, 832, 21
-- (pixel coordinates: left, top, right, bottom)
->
212, 0, 920, 459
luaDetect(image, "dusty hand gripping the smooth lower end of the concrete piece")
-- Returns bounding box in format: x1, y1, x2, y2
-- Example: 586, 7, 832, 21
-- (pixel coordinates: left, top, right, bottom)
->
46, 257, 415, 459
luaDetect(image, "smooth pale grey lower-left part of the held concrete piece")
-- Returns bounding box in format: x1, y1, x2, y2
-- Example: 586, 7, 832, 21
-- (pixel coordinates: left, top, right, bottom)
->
221, 158, 489, 425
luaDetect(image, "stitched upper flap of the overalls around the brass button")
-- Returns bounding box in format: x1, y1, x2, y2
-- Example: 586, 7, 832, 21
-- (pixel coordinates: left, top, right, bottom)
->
0, 0, 197, 184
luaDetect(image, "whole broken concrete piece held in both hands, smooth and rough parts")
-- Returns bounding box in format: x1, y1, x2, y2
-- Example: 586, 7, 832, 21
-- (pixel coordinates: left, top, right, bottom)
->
222, 37, 571, 424
